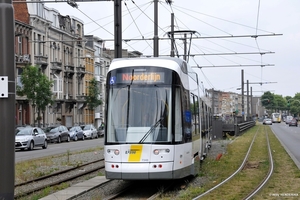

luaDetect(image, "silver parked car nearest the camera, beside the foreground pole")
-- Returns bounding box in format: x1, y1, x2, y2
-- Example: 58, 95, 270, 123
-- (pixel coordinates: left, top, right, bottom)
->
15, 127, 48, 150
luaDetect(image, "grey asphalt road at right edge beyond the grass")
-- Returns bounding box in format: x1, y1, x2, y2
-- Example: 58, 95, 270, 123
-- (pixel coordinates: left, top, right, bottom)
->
270, 122, 300, 169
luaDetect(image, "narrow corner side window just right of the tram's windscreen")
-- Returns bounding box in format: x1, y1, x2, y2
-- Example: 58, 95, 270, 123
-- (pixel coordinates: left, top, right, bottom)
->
174, 88, 182, 142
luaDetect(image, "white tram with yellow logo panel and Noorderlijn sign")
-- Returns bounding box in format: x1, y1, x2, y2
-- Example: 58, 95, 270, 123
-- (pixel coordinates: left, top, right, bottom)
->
104, 58, 207, 180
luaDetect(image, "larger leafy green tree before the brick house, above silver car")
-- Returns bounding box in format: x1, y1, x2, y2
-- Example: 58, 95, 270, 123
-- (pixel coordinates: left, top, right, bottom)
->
17, 65, 53, 126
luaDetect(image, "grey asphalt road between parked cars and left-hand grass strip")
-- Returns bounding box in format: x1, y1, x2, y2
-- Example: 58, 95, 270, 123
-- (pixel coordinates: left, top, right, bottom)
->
15, 137, 104, 163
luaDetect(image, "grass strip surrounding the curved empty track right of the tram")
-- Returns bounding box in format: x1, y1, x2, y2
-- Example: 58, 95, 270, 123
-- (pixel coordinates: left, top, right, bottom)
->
161, 125, 300, 200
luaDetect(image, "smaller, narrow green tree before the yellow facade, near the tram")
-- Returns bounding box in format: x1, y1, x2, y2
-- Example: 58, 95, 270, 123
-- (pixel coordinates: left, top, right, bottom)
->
86, 78, 102, 110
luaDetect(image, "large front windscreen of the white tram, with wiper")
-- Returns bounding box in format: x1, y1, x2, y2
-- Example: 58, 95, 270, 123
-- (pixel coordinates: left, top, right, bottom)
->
107, 85, 171, 143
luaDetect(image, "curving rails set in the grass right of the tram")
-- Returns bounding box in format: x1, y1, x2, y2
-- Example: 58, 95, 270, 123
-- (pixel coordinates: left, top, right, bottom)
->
193, 127, 274, 200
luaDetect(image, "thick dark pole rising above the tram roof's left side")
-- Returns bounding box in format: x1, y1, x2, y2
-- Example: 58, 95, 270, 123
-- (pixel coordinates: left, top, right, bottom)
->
114, 0, 122, 58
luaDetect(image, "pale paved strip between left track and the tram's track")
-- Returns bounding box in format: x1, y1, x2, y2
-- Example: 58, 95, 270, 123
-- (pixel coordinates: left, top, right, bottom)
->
40, 176, 109, 200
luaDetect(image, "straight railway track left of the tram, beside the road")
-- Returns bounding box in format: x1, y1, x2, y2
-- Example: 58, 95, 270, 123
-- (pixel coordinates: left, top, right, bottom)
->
14, 159, 104, 199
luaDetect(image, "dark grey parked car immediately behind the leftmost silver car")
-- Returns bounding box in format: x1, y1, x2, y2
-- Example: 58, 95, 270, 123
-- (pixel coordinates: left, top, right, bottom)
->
45, 125, 70, 143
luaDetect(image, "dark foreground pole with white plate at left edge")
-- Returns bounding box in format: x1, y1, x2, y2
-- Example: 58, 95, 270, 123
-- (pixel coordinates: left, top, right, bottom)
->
0, 0, 16, 200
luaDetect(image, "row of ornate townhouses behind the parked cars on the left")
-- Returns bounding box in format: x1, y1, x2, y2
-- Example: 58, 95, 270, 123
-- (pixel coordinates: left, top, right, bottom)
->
13, 1, 141, 127
